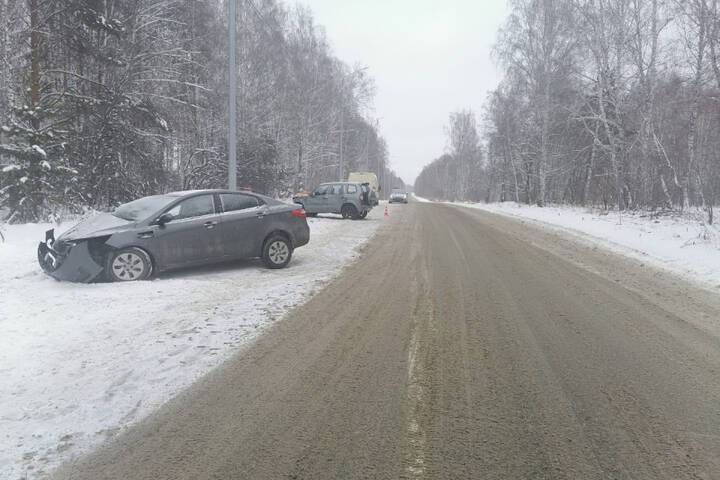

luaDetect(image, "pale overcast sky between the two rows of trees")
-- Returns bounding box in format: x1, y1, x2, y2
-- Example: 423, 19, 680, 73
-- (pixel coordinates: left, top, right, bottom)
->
299, 0, 508, 183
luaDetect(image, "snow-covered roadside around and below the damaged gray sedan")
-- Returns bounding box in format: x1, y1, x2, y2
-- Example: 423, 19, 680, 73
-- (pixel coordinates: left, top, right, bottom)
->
0, 208, 384, 480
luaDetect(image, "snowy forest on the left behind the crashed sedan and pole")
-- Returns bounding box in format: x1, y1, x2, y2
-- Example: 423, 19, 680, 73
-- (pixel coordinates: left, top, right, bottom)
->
0, 0, 402, 223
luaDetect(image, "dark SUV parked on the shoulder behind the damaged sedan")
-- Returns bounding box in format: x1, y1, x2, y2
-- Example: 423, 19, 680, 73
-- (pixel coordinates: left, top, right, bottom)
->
293, 182, 373, 220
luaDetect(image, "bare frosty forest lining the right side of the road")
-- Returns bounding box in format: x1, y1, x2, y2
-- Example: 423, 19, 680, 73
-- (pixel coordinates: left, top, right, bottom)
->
416, 0, 720, 222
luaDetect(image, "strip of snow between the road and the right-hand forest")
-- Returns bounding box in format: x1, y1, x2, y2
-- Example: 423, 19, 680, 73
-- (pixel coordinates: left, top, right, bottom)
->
458, 202, 720, 290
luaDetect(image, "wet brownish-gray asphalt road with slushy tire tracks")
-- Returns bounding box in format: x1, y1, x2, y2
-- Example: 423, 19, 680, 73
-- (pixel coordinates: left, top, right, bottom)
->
56, 203, 720, 480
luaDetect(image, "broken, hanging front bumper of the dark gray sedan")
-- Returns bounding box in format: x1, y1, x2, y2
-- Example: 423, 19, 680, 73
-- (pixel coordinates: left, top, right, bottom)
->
38, 230, 104, 283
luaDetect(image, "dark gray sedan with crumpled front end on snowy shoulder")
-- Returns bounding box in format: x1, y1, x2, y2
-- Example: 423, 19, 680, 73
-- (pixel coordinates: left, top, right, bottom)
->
38, 190, 310, 282
